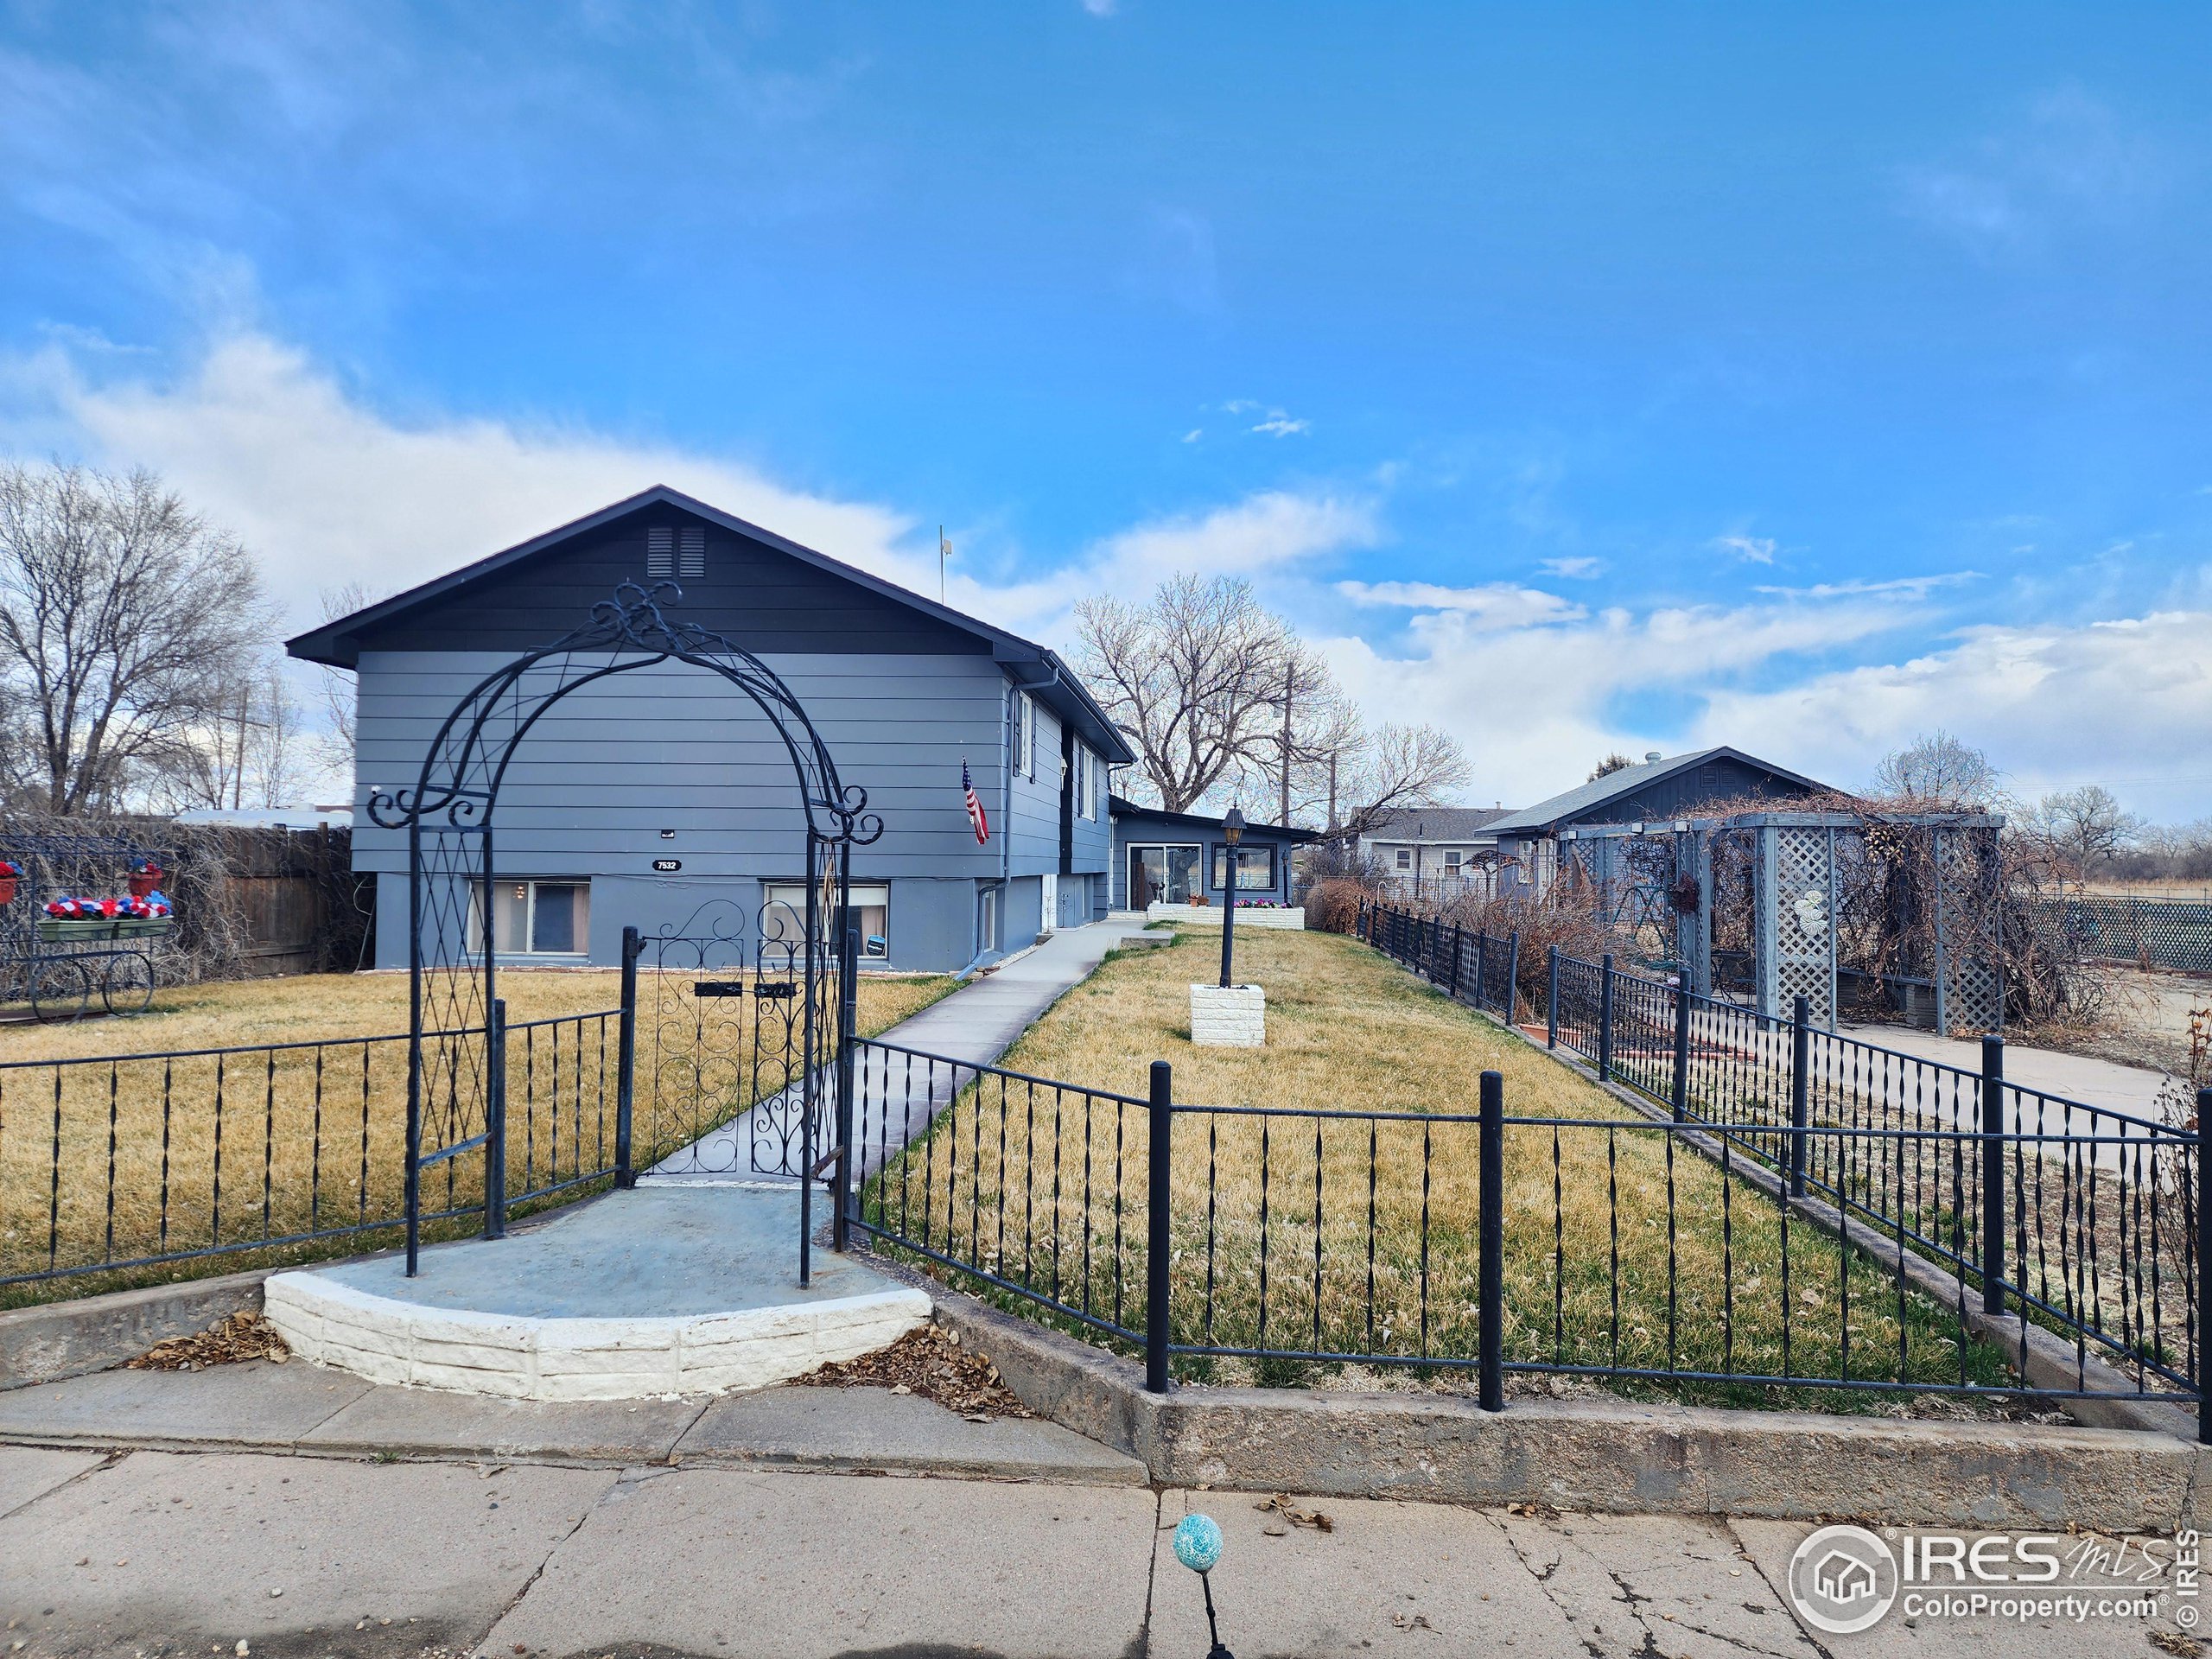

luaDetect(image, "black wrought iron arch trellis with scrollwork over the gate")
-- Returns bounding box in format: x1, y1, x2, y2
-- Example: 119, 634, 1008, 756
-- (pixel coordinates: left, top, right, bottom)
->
370, 582, 882, 1276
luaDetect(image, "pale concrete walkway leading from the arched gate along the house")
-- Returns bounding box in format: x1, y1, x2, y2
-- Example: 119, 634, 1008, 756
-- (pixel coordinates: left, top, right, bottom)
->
641, 916, 1166, 1185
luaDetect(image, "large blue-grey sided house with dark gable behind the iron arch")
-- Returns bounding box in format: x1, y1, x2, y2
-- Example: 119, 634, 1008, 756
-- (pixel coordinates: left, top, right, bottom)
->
288, 486, 1135, 971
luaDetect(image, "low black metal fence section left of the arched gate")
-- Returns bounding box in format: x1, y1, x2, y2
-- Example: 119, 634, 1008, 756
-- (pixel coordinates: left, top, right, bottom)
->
0, 1008, 631, 1299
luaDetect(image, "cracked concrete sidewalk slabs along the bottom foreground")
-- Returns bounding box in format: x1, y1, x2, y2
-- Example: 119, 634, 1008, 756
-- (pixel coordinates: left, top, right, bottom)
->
0, 1446, 2158, 1659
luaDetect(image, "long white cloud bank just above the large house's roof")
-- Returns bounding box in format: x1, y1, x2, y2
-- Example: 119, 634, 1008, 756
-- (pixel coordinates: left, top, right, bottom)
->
0, 334, 1382, 654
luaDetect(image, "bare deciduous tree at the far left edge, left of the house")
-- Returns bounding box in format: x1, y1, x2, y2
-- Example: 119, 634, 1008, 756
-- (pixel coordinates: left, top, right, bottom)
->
0, 465, 270, 814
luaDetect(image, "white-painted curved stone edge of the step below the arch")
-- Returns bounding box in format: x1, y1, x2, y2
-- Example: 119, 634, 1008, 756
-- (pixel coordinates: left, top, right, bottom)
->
264, 1272, 929, 1400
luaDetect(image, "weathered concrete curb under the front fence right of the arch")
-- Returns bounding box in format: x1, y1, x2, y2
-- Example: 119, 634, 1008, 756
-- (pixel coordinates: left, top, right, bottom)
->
878, 1256, 2203, 1533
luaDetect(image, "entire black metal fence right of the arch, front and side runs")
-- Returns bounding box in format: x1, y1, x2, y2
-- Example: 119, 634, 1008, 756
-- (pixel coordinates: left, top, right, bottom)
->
849, 913, 2212, 1435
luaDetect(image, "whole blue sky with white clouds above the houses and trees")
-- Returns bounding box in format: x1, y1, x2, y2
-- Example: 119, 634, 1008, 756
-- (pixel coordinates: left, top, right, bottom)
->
0, 0, 2212, 818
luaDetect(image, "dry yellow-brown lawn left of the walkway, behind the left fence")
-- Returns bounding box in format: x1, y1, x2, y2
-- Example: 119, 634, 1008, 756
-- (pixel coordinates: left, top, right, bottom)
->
0, 971, 951, 1305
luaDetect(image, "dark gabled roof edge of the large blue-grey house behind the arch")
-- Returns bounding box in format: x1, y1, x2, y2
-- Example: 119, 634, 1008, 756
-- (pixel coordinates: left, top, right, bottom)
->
285, 485, 1137, 766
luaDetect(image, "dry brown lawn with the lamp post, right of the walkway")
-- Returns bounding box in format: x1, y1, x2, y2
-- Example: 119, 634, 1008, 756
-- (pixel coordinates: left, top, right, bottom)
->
869, 929, 2004, 1402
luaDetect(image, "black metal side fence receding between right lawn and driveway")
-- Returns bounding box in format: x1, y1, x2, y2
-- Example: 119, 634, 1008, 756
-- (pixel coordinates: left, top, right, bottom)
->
1363, 912, 2212, 1424
